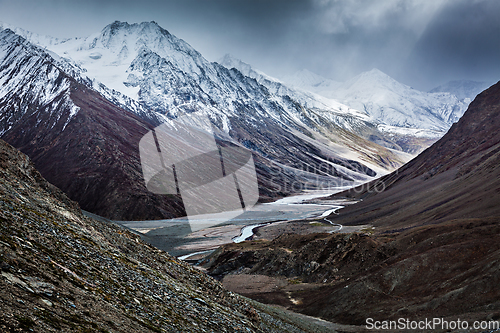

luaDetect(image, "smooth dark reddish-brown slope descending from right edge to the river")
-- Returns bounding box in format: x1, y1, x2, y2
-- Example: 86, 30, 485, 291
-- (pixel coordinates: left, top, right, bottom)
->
334, 79, 500, 229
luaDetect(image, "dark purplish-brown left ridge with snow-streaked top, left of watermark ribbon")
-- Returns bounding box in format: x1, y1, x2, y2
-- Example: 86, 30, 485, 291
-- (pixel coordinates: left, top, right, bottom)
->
0, 30, 189, 219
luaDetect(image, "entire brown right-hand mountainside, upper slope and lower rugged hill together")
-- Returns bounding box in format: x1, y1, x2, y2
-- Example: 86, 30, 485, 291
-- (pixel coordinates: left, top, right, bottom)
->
202, 83, 500, 324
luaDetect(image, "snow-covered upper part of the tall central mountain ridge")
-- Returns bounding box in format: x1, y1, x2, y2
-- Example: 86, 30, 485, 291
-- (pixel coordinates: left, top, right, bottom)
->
32, 22, 422, 158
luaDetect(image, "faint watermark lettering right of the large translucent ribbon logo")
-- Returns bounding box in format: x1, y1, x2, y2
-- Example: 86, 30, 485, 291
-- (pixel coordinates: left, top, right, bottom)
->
268, 158, 392, 193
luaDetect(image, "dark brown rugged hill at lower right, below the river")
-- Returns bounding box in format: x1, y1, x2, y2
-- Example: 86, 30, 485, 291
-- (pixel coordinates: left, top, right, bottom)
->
206, 217, 500, 325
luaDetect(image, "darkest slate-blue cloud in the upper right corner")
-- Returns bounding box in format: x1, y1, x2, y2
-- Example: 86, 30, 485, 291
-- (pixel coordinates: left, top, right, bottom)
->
407, 1, 500, 87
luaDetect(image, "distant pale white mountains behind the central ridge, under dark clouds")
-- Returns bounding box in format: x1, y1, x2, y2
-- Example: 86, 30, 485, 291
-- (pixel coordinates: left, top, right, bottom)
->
220, 54, 491, 137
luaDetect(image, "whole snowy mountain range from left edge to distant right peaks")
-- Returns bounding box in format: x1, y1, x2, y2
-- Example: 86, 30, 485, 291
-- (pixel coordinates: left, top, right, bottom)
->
0, 21, 488, 219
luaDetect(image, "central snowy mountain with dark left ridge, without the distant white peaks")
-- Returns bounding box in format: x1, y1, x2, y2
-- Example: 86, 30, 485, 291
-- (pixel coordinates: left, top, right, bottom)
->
0, 22, 394, 220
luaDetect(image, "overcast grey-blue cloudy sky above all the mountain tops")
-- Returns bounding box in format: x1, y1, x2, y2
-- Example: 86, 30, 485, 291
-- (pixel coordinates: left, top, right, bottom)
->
0, 0, 500, 90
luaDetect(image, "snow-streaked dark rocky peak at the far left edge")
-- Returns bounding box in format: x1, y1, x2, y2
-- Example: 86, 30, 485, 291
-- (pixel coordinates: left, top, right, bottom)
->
0, 28, 79, 135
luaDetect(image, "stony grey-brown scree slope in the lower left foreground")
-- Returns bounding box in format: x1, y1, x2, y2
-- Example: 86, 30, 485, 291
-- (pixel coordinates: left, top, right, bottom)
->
0, 141, 328, 332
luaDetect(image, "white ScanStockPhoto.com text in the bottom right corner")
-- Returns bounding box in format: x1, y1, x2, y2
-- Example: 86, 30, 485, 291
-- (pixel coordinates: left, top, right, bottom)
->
365, 318, 500, 331
